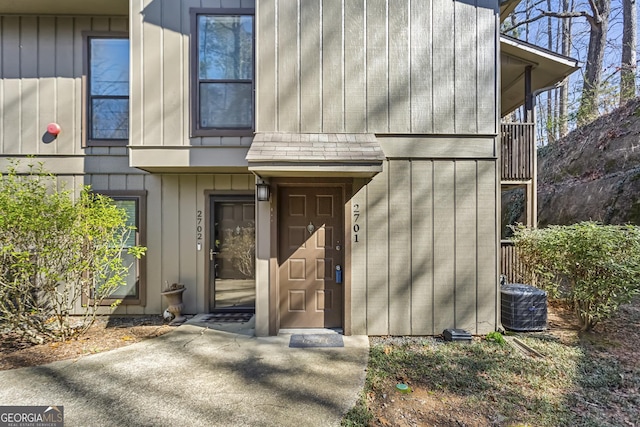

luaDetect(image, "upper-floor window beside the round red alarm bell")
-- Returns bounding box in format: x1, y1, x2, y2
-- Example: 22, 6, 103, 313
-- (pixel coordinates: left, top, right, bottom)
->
86, 36, 129, 145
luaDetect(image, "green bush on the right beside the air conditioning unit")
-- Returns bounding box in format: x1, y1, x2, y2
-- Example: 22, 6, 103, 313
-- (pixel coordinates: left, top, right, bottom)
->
513, 221, 640, 331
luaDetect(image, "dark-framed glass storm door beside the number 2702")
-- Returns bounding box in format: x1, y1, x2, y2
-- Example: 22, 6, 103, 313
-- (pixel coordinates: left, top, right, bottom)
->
209, 196, 256, 311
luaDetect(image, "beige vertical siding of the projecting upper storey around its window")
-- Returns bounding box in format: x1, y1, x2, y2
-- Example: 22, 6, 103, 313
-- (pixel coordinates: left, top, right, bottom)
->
126, 0, 498, 146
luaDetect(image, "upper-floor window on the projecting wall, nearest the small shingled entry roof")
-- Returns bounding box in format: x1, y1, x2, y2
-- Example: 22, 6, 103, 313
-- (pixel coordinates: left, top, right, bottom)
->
192, 11, 254, 136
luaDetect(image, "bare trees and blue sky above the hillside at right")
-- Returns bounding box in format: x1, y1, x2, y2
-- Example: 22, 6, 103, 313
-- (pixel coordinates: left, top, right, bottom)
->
503, 0, 637, 145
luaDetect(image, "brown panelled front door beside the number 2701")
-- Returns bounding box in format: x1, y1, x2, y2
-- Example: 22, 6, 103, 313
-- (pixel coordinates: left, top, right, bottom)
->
278, 187, 344, 328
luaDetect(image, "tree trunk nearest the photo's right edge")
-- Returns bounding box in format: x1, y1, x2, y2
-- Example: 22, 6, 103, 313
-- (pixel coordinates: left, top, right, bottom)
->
620, 0, 637, 105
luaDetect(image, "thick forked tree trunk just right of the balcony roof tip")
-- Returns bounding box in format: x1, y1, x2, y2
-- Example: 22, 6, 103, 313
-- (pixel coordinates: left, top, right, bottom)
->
578, 0, 611, 126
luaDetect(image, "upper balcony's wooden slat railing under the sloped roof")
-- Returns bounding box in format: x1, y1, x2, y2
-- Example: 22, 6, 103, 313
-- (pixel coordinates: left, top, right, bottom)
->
500, 123, 536, 181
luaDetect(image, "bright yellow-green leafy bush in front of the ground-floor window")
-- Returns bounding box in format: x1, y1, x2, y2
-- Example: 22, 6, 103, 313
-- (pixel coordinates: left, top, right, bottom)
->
0, 163, 145, 342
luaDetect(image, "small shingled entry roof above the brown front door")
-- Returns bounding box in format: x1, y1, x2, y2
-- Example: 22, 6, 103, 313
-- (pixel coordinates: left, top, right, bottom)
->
246, 132, 385, 178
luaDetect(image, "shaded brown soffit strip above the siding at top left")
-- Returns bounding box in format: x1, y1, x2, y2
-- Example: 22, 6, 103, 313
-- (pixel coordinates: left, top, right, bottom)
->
0, 0, 129, 16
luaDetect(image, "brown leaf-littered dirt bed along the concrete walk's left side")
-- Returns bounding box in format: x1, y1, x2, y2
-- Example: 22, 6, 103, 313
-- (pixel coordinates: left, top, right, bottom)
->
0, 316, 174, 370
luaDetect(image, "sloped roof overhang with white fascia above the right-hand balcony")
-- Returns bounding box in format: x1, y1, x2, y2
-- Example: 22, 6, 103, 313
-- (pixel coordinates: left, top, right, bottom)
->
500, 35, 580, 117
